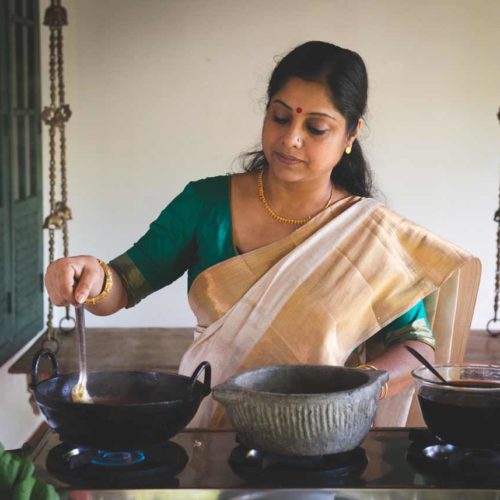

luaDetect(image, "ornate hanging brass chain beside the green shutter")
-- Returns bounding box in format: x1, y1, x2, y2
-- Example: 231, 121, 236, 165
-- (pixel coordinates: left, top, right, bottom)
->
42, 0, 74, 352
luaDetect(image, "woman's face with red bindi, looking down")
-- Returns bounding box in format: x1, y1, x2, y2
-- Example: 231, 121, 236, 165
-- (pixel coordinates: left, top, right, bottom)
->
262, 78, 361, 186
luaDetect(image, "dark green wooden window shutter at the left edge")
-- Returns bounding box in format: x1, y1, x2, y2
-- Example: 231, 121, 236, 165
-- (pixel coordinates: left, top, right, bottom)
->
0, 0, 43, 363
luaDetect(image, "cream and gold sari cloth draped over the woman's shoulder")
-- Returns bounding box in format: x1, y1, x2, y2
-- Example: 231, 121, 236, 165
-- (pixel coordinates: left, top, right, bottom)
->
179, 196, 480, 427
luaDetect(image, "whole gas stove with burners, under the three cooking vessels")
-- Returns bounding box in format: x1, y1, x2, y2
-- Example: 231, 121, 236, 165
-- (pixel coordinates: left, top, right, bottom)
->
17, 428, 500, 499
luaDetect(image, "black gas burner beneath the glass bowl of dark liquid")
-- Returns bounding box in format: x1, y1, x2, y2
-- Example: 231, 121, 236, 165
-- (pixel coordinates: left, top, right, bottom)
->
406, 429, 500, 486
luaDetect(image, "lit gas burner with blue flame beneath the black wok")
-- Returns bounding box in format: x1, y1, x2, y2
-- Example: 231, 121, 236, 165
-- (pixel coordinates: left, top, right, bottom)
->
47, 442, 188, 488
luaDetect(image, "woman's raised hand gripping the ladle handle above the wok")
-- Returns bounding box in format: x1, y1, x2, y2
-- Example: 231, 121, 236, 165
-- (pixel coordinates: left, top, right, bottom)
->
45, 255, 105, 306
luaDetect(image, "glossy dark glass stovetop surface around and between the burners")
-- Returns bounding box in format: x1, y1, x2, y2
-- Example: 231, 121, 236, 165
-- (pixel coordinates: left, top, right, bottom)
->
25, 429, 500, 498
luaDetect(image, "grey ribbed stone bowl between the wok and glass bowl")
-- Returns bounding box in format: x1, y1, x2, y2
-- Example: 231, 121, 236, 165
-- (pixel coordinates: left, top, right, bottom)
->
212, 365, 389, 456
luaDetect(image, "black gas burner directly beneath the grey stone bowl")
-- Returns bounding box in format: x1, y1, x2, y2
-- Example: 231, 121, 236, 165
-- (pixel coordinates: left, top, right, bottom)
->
229, 444, 368, 487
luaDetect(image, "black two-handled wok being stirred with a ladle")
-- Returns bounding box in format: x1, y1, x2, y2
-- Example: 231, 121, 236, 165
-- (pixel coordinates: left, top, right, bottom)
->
32, 350, 211, 451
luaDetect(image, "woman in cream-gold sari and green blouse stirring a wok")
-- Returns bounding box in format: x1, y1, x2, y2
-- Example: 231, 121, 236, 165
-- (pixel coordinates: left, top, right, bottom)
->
46, 42, 474, 426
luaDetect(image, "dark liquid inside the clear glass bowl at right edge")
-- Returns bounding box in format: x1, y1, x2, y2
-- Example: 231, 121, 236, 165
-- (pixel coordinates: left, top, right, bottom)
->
418, 380, 500, 448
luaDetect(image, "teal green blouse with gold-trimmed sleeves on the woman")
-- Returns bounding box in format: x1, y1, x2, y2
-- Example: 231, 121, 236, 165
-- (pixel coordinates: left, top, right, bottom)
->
110, 175, 435, 347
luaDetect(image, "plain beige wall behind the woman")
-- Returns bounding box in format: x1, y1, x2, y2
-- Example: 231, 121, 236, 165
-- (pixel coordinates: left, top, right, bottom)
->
0, 0, 500, 448
